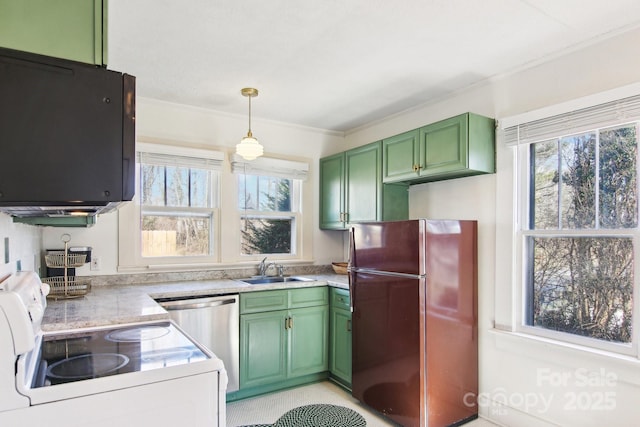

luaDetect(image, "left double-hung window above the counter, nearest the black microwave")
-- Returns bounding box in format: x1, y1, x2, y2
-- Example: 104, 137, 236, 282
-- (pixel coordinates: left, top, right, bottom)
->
120, 143, 224, 266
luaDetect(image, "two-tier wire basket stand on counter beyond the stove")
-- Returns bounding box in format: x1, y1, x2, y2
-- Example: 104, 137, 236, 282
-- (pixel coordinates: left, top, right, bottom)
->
42, 234, 91, 300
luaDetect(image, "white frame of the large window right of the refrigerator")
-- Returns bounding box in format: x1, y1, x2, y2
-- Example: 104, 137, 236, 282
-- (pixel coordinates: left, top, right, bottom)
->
494, 85, 640, 359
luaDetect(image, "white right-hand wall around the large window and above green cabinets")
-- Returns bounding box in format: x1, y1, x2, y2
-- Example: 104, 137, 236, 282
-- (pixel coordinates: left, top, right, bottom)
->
346, 25, 640, 426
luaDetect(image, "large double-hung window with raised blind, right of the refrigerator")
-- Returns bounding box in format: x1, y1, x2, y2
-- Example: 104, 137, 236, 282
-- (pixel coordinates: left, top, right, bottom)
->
504, 97, 640, 354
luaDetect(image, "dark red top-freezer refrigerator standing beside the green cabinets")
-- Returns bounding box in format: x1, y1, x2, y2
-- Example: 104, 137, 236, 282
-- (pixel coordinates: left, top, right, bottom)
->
349, 219, 478, 427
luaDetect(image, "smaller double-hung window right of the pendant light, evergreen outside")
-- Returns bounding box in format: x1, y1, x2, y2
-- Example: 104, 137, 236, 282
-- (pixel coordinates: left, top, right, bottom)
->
232, 157, 308, 259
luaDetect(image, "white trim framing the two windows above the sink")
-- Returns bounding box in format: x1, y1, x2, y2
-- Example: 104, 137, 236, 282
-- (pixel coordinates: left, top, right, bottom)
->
117, 144, 317, 273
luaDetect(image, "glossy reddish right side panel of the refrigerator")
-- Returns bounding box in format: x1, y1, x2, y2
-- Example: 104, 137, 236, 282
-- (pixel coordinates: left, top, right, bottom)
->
425, 221, 478, 426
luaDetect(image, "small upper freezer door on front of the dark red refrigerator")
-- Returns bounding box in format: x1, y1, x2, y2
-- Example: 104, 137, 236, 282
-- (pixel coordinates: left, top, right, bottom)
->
350, 219, 426, 276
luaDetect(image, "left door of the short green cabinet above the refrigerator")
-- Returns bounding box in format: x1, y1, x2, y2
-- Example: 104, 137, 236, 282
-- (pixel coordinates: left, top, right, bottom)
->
382, 129, 420, 182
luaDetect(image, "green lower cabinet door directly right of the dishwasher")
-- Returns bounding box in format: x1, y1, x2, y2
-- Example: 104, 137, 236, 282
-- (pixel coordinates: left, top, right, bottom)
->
240, 310, 288, 389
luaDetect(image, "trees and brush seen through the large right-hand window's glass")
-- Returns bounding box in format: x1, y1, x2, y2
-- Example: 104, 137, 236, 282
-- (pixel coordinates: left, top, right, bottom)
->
524, 123, 638, 343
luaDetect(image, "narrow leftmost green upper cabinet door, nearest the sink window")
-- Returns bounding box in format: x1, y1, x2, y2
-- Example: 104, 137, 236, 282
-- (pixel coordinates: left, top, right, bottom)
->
320, 153, 345, 230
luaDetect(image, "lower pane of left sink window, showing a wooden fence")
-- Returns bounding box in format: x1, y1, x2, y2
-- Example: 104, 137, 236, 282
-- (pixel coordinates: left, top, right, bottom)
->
142, 214, 212, 257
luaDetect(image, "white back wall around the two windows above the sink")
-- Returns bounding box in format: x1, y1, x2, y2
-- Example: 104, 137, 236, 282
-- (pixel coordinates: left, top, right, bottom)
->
43, 98, 344, 275
